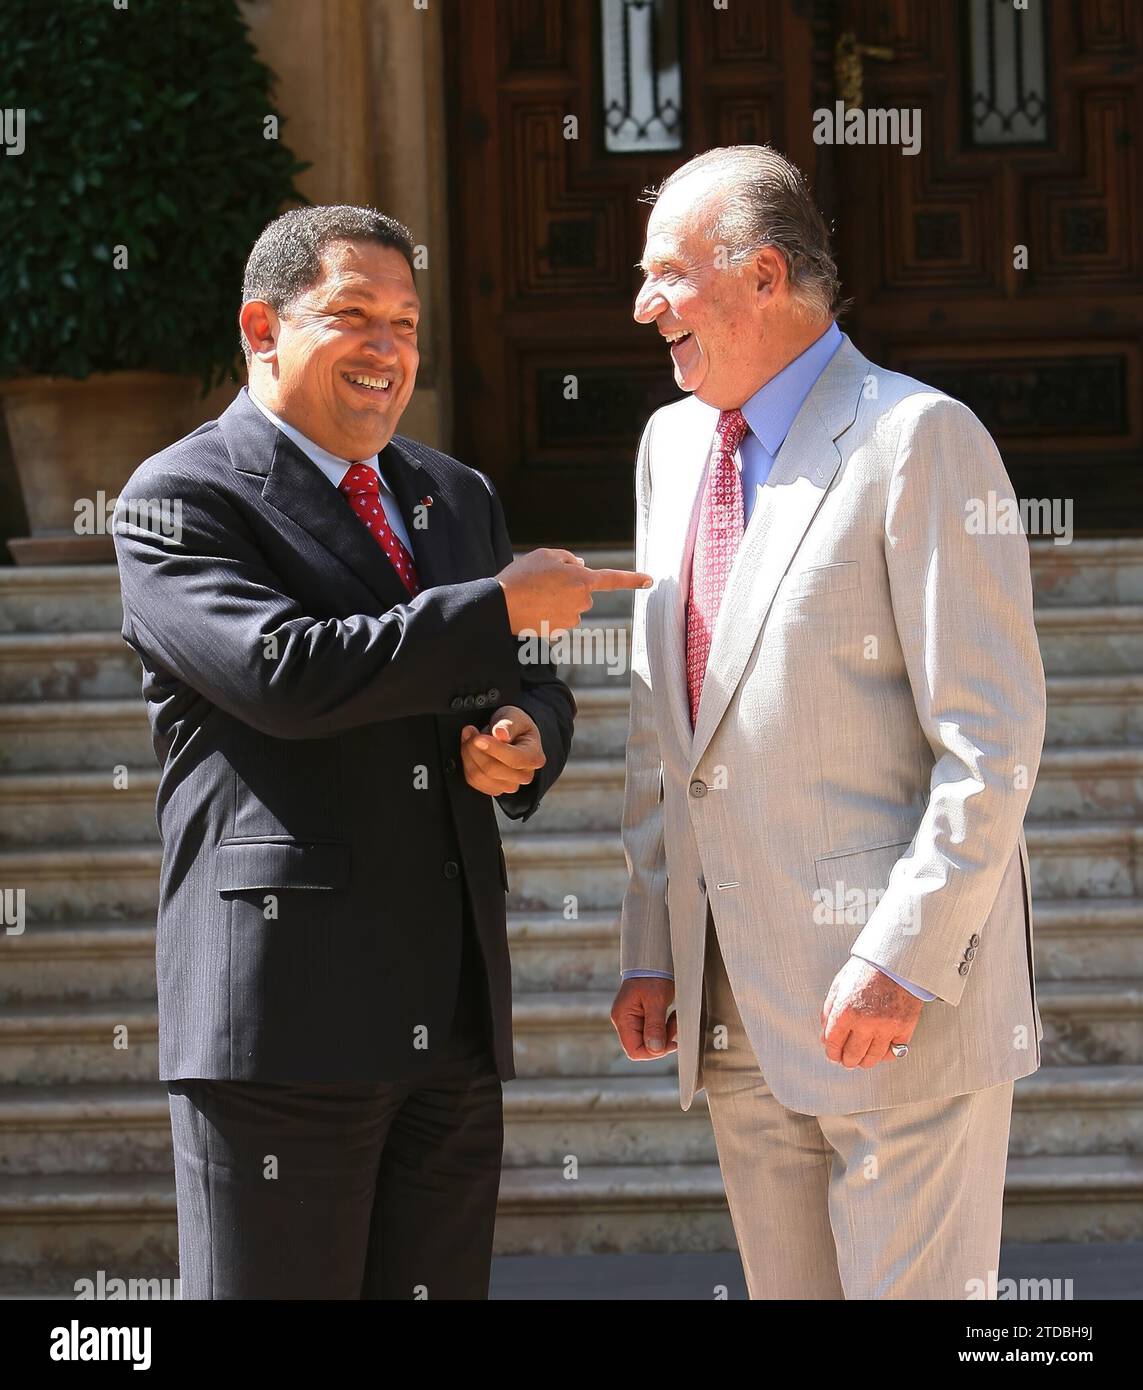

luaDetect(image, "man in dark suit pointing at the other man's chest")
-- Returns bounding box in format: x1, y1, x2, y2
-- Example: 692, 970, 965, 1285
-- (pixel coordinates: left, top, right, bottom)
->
115, 207, 653, 1298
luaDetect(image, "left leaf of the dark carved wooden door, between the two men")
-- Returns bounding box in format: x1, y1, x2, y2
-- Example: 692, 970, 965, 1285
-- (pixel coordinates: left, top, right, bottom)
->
445, 0, 813, 543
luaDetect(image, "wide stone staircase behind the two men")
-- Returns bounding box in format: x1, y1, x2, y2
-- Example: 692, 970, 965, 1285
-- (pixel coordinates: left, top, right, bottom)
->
0, 539, 1143, 1295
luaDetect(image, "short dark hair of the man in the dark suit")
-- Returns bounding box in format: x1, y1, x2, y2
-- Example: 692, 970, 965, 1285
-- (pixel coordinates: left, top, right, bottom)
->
239, 203, 416, 361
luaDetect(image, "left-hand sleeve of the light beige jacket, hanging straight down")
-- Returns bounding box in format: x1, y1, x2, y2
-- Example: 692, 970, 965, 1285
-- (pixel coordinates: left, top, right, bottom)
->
619, 416, 674, 976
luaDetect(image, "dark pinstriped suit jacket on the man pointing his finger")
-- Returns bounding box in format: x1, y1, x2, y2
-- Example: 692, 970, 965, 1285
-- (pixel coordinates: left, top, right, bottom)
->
115, 389, 576, 1081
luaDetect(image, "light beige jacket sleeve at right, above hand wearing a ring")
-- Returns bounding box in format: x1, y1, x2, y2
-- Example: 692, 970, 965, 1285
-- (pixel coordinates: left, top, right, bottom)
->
852, 395, 1046, 1004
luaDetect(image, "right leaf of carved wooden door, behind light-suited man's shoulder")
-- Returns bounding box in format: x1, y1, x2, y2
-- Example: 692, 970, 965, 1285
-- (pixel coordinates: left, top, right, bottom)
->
822, 0, 1143, 532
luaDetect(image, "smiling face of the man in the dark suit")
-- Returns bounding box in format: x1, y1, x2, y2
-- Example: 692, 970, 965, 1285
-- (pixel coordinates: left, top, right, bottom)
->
241, 242, 420, 460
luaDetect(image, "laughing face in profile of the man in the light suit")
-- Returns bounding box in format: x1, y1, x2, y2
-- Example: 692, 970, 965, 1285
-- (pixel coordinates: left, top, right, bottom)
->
634, 175, 786, 410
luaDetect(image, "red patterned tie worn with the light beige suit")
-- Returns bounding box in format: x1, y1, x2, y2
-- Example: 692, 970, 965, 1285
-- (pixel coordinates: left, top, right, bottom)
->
687, 410, 747, 727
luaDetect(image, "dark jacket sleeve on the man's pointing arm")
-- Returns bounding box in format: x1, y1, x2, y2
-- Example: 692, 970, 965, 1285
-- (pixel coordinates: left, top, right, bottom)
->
114, 466, 520, 738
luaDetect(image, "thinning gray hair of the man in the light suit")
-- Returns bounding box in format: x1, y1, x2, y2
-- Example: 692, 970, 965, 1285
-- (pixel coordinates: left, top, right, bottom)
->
642, 145, 848, 317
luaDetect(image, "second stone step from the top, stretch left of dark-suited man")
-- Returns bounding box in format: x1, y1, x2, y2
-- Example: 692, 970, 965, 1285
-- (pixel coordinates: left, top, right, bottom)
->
0, 631, 143, 702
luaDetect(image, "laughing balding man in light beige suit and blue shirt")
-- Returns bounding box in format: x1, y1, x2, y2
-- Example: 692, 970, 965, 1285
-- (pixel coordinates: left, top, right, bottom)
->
612, 146, 1044, 1298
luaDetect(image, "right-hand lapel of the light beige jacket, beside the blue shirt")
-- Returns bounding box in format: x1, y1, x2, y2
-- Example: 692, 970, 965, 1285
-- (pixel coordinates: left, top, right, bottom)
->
684, 338, 869, 769
